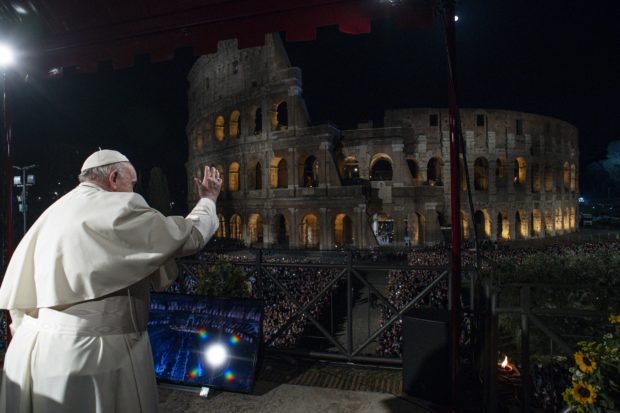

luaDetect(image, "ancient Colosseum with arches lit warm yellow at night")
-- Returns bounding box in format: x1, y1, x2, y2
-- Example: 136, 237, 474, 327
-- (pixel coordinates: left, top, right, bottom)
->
186, 35, 579, 250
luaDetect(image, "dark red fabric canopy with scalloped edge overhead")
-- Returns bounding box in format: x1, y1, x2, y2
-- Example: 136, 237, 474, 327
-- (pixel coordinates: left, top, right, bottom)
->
0, 0, 434, 71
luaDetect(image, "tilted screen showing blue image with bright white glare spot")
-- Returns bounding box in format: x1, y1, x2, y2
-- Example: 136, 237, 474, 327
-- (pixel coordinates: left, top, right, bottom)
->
148, 293, 263, 393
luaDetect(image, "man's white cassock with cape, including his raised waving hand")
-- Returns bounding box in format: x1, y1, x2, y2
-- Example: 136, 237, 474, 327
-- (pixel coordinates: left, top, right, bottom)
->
0, 183, 219, 413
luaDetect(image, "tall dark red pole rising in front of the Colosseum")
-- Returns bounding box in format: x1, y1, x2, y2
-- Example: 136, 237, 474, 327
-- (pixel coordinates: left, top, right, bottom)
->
443, 0, 461, 406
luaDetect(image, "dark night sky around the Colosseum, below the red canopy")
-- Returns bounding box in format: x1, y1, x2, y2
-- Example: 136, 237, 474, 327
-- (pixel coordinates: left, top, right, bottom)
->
8, 0, 620, 219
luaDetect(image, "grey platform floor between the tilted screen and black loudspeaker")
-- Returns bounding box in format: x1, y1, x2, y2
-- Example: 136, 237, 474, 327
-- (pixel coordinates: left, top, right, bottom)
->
159, 358, 436, 413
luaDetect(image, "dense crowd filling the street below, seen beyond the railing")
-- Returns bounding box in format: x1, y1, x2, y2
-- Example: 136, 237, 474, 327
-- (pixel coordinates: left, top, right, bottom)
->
171, 241, 620, 357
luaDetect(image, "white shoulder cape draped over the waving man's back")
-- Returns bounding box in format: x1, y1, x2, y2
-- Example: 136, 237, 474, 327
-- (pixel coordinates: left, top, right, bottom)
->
0, 184, 197, 310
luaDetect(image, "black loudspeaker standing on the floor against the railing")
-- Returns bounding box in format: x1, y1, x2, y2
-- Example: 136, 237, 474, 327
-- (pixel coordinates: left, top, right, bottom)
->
402, 308, 451, 405
